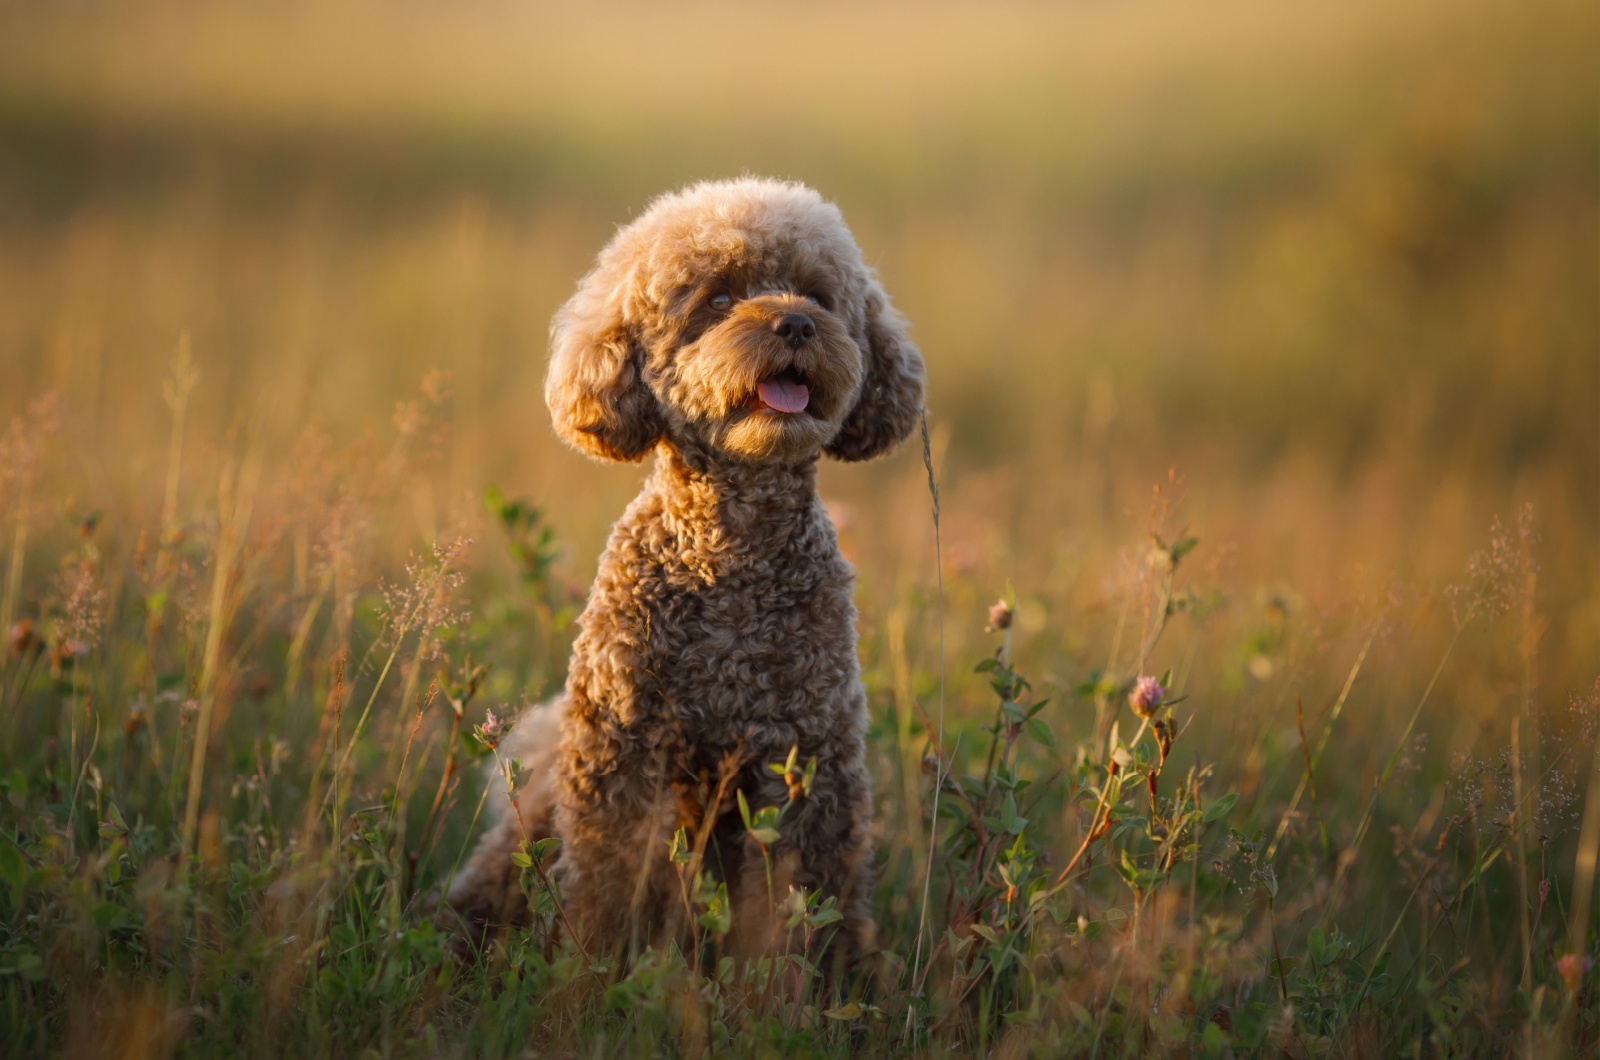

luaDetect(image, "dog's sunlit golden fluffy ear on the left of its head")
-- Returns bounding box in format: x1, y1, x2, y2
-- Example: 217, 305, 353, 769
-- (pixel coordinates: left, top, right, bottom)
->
544, 264, 664, 461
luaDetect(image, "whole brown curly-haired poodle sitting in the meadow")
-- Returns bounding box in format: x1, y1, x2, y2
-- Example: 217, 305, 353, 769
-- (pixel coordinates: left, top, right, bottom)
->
450, 179, 923, 959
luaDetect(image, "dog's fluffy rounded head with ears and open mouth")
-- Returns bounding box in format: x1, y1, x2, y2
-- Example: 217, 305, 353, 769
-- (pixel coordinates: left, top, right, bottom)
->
544, 179, 923, 463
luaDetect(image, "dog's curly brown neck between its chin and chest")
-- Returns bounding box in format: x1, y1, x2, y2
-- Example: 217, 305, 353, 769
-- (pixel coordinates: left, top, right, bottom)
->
648, 445, 816, 557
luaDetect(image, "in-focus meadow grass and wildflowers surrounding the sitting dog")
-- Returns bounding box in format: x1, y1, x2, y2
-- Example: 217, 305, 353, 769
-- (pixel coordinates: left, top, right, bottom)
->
0, 376, 1600, 1057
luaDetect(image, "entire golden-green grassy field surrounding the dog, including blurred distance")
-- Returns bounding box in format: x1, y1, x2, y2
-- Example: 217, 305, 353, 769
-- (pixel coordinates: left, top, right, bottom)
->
0, 0, 1600, 1057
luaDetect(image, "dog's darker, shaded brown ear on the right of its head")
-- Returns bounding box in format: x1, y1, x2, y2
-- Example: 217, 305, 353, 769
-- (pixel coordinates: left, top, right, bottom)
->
827, 280, 923, 460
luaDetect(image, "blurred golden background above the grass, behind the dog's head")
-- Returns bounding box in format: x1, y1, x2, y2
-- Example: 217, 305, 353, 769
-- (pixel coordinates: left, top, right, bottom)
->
0, 0, 1600, 717
